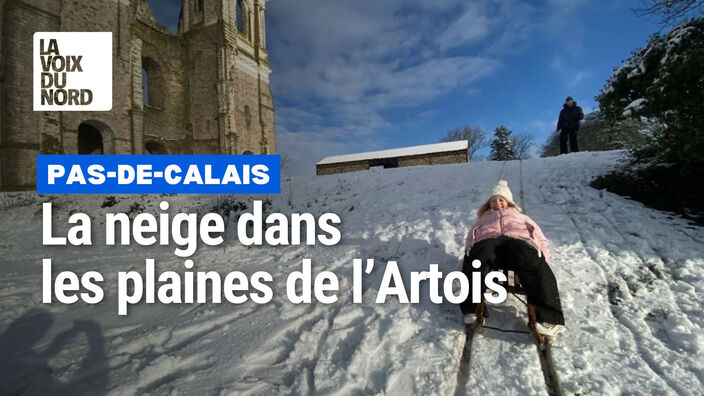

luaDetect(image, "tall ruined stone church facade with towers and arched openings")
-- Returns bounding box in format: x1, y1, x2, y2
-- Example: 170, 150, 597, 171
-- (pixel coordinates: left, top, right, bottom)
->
0, 0, 276, 191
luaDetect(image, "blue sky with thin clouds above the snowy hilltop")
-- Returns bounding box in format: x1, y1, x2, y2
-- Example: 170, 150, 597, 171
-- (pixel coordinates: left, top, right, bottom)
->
149, 0, 662, 175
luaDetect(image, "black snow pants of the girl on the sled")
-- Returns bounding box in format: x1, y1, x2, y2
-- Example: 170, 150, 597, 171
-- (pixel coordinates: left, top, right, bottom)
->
460, 237, 565, 325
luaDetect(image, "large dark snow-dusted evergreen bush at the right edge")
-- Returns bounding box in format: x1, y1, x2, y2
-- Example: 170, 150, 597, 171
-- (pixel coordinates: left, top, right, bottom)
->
593, 17, 704, 223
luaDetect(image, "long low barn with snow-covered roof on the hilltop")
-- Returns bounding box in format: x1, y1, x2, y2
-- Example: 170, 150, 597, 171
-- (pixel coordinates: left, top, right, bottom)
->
315, 140, 469, 175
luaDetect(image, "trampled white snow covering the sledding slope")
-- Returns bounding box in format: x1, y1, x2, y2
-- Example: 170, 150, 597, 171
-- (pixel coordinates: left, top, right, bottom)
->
0, 152, 704, 395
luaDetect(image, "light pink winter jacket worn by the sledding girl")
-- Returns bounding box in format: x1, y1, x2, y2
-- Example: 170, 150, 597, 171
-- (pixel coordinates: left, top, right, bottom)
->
465, 208, 550, 260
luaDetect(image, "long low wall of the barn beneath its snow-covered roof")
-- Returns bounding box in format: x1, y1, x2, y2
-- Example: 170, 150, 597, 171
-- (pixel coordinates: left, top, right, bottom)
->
315, 149, 469, 175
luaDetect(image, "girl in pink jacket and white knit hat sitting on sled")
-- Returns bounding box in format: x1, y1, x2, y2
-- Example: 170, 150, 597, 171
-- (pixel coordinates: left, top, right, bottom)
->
460, 180, 565, 337
